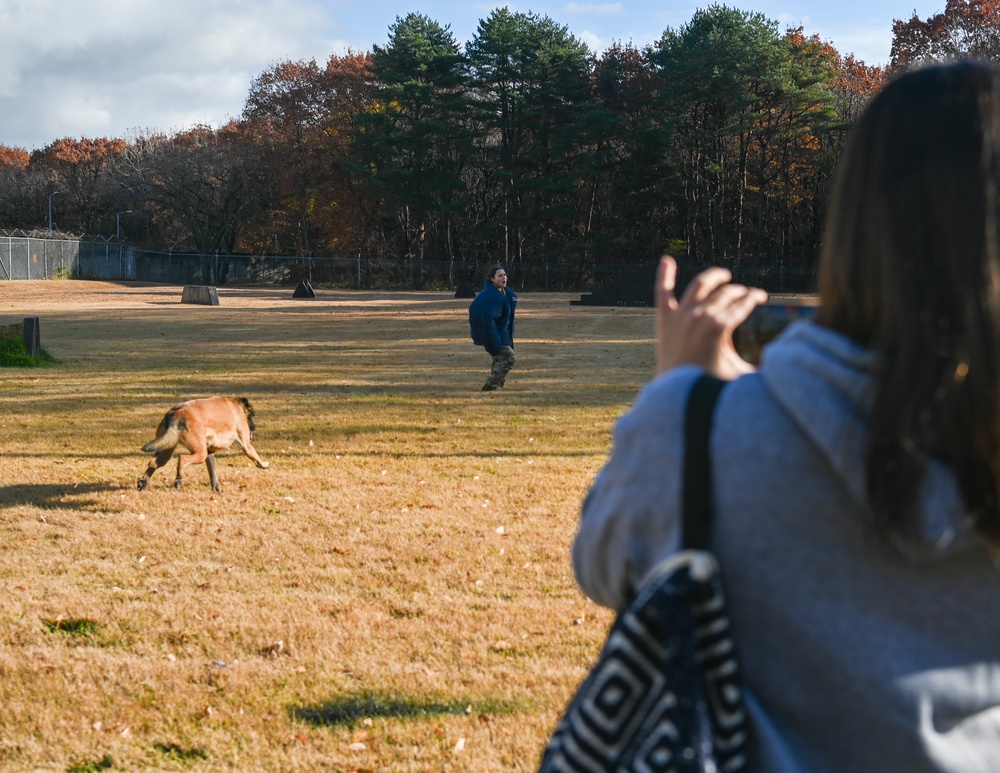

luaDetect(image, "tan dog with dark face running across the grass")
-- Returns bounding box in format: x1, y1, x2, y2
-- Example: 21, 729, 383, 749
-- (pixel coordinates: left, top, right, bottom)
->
137, 397, 270, 491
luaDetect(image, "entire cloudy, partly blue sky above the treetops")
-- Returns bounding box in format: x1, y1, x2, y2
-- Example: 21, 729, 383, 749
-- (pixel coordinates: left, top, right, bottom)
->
0, 0, 945, 150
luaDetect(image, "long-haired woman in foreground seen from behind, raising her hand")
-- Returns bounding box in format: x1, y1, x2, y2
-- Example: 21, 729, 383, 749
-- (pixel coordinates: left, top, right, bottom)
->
573, 62, 1000, 773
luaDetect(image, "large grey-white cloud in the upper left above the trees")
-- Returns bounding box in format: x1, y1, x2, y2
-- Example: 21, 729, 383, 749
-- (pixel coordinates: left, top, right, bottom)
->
0, 0, 335, 149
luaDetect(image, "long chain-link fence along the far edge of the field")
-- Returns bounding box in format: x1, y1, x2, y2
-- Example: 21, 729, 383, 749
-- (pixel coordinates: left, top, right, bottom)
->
0, 234, 816, 296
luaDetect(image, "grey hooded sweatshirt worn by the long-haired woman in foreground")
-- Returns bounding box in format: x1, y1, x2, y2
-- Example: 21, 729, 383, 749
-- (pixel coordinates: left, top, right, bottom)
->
573, 322, 1000, 773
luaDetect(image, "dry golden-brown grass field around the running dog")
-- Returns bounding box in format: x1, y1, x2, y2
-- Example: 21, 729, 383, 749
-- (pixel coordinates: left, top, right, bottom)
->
0, 281, 652, 773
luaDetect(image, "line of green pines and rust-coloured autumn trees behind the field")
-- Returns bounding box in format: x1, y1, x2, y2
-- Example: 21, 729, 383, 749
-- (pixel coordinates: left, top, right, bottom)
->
0, 0, 1000, 280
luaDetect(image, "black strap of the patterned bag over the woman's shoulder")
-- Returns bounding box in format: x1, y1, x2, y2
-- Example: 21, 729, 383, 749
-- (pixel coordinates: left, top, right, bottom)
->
681, 373, 728, 550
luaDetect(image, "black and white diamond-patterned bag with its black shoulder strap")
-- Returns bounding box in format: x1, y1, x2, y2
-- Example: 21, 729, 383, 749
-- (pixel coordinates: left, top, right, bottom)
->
540, 376, 748, 773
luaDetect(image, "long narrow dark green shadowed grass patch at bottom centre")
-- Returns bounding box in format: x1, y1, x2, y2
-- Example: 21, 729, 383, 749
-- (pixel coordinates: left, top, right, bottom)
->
289, 692, 518, 727
